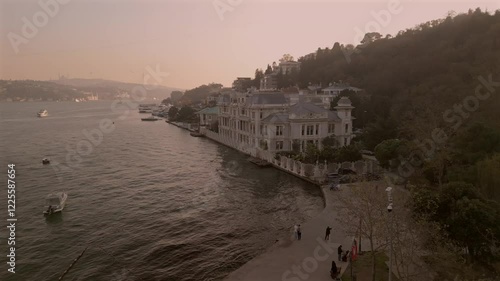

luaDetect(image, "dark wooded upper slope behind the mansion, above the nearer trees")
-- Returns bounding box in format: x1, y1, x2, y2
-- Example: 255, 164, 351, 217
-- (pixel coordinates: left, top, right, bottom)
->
274, 9, 500, 136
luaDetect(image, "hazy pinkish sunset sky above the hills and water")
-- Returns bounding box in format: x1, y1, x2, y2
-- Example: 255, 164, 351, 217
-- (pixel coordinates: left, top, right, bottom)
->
0, 0, 500, 89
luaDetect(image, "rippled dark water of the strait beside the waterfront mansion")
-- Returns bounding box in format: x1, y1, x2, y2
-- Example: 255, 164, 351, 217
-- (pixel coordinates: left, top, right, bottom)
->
0, 101, 323, 281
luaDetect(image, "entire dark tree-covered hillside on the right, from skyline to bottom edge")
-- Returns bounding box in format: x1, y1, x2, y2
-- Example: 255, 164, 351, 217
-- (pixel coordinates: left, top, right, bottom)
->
247, 8, 500, 280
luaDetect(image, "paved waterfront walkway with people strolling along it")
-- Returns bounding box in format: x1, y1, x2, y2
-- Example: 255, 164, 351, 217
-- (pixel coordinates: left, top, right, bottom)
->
224, 185, 352, 281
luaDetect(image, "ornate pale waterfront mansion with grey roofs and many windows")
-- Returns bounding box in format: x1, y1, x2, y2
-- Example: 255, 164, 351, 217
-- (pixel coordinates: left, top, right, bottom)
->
218, 91, 354, 152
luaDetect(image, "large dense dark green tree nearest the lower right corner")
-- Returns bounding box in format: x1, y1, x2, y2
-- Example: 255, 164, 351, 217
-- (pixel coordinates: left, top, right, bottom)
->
412, 182, 500, 262
